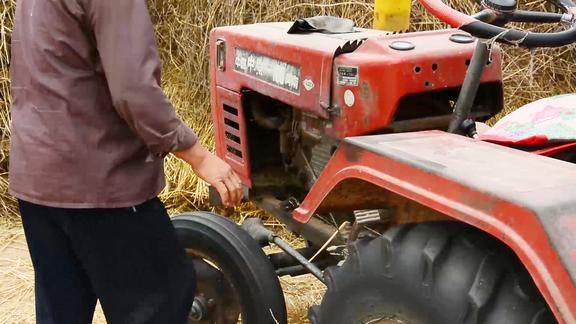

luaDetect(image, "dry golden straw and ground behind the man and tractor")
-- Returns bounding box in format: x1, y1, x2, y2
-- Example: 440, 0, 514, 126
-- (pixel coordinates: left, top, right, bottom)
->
0, 0, 576, 323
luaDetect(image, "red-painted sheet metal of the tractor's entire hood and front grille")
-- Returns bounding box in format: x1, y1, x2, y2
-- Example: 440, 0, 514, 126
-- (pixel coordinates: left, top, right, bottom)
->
210, 23, 502, 182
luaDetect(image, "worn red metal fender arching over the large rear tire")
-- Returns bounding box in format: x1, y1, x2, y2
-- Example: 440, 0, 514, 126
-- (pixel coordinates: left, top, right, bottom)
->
294, 131, 576, 323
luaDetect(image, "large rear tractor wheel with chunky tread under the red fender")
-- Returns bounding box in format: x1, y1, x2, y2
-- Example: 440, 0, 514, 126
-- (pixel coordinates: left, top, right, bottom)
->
309, 222, 556, 324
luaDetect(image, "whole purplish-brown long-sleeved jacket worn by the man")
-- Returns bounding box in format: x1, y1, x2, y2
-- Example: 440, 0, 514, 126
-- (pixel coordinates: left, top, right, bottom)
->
10, 0, 197, 208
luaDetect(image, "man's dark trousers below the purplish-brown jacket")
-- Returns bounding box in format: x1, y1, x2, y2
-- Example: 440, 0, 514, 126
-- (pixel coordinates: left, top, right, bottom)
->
19, 199, 195, 324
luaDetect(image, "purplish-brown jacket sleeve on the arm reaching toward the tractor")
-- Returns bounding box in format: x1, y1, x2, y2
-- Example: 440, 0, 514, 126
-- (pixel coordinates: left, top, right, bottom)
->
84, 0, 197, 158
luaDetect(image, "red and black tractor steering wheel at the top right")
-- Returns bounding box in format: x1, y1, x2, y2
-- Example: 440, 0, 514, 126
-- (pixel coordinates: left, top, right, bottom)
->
420, 0, 576, 48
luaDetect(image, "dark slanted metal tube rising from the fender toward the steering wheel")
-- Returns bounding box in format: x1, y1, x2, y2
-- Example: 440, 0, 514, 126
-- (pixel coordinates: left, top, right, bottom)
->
448, 39, 490, 133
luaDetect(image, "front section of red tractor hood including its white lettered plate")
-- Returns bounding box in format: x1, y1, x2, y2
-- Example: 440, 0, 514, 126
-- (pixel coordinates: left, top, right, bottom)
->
211, 22, 388, 118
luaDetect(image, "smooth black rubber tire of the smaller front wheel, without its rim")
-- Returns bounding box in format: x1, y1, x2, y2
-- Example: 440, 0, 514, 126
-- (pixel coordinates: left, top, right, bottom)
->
172, 212, 287, 324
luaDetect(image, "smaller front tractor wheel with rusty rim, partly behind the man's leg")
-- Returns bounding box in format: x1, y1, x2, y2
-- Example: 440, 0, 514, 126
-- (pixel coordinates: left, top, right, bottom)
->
172, 212, 287, 324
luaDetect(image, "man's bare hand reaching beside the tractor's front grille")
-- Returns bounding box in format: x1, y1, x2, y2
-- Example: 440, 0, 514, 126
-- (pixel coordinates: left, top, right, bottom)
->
173, 143, 243, 207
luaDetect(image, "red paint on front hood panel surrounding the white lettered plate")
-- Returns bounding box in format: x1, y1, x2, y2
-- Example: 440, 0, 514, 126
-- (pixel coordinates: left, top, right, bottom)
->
210, 24, 345, 118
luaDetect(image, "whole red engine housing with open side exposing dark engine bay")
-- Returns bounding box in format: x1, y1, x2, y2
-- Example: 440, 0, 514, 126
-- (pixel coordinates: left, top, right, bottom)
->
211, 23, 503, 200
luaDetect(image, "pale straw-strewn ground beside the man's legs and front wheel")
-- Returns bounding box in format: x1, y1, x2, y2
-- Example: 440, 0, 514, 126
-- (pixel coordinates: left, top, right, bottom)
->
0, 227, 323, 324
